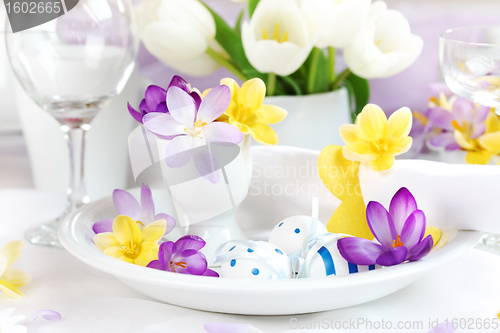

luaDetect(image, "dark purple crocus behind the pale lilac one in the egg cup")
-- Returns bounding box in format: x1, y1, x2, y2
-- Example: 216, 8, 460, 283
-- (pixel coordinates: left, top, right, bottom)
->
127, 75, 201, 124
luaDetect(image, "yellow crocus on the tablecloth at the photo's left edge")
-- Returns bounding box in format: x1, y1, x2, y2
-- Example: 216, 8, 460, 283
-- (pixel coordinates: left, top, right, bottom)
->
0, 241, 31, 298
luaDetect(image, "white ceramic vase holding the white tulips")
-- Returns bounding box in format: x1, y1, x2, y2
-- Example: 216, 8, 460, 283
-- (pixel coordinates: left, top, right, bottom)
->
264, 88, 352, 150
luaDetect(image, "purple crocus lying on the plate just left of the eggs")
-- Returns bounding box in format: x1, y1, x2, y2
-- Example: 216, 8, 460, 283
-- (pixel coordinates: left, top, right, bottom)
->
147, 235, 219, 277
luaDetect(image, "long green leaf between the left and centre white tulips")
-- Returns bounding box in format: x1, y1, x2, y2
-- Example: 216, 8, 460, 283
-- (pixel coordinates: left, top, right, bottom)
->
205, 5, 267, 81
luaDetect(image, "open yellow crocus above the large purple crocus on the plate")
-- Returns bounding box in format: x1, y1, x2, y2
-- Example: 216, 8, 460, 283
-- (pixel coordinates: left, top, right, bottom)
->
340, 104, 412, 171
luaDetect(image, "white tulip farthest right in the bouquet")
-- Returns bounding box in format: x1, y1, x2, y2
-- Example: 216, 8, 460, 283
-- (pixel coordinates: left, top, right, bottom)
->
344, 1, 424, 79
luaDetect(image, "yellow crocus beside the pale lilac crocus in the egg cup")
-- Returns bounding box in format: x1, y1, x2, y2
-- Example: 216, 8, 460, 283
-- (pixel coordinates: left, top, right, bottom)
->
219, 78, 288, 145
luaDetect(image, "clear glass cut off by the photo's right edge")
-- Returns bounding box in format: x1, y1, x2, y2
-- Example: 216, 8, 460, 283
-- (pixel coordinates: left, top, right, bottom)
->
439, 26, 500, 254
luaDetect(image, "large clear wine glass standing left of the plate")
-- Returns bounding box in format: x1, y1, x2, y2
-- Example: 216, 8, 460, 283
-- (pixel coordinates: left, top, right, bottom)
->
6, 0, 139, 247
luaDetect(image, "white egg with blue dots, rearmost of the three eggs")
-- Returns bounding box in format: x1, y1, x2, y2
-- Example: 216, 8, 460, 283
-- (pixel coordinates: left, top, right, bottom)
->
269, 215, 328, 255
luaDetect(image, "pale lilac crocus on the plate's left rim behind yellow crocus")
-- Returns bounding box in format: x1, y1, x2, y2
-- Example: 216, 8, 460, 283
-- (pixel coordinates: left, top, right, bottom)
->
92, 183, 175, 235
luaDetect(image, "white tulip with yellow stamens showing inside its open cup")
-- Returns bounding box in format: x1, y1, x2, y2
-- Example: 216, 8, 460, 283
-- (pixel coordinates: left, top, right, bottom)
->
241, 0, 316, 76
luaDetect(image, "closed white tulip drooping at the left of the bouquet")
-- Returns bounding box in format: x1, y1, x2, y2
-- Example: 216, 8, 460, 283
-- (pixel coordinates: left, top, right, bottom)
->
136, 0, 219, 76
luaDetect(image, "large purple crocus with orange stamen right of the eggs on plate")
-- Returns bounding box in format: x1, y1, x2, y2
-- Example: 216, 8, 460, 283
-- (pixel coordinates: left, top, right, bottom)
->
337, 187, 433, 266
